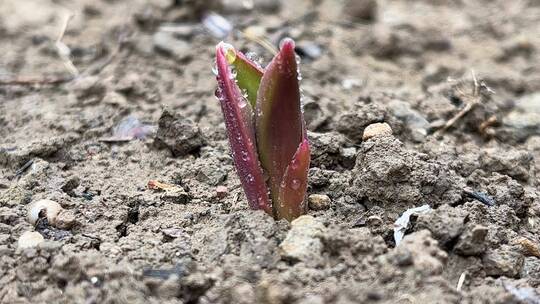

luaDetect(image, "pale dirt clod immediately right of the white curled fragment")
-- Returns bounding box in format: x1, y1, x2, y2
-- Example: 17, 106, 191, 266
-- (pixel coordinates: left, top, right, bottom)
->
415, 204, 468, 247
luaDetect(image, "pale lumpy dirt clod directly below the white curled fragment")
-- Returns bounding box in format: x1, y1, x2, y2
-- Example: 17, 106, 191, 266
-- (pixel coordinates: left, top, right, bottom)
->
393, 230, 448, 276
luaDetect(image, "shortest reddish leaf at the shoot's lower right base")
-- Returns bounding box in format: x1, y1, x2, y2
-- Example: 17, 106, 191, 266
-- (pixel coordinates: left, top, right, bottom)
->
274, 139, 310, 221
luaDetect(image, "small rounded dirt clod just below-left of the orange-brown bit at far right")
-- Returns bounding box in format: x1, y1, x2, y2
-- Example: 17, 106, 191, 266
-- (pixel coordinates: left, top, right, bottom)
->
482, 245, 524, 278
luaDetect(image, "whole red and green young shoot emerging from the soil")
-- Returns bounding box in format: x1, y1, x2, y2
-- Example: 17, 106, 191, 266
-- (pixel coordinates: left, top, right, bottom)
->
216, 38, 310, 221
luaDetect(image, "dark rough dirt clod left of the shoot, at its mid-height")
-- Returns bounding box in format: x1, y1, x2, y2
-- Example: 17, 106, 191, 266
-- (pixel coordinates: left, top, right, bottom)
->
155, 109, 205, 157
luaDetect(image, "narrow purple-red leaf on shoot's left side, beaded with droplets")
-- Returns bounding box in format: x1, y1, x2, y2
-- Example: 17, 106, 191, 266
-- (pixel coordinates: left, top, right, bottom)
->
216, 43, 272, 214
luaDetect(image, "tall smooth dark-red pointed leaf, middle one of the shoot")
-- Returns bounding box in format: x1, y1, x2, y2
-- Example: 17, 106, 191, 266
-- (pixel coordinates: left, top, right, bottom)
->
255, 39, 305, 213
